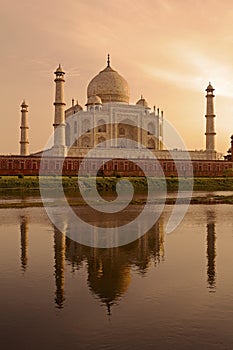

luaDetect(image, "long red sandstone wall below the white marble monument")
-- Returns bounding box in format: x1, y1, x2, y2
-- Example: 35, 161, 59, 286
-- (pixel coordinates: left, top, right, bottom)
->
0, 156, 233, 177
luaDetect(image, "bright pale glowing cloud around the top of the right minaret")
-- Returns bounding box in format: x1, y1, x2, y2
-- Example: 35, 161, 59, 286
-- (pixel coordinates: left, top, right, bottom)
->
141, 39, 233, 97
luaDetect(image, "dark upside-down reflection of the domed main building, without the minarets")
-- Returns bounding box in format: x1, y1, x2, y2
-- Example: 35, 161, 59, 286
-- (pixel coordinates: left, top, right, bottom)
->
62, 223, 164, 315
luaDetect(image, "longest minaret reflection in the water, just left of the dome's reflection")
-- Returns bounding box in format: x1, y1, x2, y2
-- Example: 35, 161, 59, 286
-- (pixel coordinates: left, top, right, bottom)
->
54, 228, 66, 309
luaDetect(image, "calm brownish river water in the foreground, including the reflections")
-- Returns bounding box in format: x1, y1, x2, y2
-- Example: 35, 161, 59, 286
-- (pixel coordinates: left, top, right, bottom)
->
0, 205, 233, 350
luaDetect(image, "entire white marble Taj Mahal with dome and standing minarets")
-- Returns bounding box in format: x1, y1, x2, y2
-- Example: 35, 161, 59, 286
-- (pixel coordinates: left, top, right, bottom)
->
20, 55, 217, 160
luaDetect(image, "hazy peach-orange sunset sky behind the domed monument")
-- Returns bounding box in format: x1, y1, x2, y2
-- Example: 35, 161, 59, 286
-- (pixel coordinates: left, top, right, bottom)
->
0, 0, 233, 154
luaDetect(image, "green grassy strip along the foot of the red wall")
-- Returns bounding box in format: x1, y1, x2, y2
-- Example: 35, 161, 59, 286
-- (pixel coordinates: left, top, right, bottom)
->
0, 176, 233, 195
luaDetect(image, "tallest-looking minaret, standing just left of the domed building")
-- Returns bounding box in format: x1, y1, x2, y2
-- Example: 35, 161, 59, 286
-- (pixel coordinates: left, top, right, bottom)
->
53, 64, 66, 156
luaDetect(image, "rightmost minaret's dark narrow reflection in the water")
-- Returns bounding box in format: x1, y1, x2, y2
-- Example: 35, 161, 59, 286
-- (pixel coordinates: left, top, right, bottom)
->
206, 211, 216, 292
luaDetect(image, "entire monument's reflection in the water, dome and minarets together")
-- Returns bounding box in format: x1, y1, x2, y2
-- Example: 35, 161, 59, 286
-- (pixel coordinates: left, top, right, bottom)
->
20, 210, 216, 314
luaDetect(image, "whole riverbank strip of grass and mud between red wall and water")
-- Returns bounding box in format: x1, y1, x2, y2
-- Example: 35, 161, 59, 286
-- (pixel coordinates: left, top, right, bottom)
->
0, 176, 233, 209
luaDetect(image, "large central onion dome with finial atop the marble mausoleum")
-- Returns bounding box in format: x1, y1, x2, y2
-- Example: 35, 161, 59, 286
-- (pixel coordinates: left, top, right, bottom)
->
87, 55, 129, 103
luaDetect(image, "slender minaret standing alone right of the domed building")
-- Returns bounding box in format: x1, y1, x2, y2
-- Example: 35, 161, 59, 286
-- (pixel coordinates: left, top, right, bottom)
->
205, 83, 216, 160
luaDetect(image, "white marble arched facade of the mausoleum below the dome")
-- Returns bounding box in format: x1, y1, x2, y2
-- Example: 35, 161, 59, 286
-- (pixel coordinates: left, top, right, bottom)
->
66, 102, 163, 156
